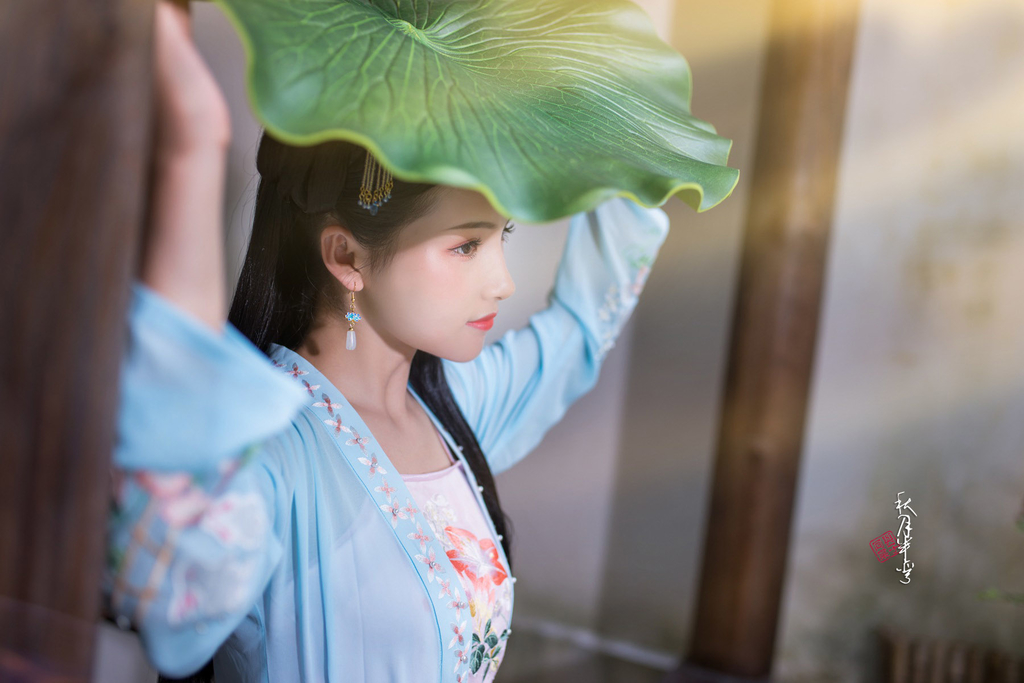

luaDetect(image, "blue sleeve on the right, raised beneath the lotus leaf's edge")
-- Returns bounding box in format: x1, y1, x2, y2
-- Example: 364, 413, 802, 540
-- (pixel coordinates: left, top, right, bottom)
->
441, 198, 669, 474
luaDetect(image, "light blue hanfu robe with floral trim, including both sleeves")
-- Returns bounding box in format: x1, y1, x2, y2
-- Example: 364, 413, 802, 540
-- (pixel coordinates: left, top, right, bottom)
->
104, 198, 669, 683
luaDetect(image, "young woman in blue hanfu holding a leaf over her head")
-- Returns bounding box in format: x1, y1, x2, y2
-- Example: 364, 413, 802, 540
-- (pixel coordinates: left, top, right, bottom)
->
106, 0, 669, 683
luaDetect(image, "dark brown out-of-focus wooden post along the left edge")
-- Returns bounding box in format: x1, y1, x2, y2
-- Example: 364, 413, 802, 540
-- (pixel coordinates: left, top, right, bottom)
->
0, 0, 154, 683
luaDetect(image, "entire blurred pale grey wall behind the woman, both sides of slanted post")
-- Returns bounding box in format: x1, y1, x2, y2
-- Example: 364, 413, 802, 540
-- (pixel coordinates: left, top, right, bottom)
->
96, 0, 1024, 683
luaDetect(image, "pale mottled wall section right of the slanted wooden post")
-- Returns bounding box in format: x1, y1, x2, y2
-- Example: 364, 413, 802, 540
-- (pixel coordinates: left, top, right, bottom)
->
777, 0, 1024, 681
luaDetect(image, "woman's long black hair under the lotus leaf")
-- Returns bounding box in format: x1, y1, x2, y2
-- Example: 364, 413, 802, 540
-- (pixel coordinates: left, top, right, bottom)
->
228, 131, 512, 572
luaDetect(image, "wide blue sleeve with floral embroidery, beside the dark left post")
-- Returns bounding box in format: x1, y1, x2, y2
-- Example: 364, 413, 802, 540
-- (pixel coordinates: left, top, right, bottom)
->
103, 283, 304, 677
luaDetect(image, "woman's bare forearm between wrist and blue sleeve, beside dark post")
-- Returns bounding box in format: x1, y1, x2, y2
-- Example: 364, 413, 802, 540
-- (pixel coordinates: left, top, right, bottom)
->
139, 144, 227, 332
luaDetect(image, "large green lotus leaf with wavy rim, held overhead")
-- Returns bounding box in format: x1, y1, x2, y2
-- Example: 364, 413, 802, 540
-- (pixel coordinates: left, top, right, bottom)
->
215, 0, 739, 222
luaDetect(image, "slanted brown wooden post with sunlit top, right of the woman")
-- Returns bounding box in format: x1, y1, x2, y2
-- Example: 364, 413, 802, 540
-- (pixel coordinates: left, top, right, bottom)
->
668, 0, 866, 683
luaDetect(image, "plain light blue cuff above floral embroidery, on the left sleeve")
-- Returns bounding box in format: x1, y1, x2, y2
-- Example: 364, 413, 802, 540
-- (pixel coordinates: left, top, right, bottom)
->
114, 282, 304, 471
